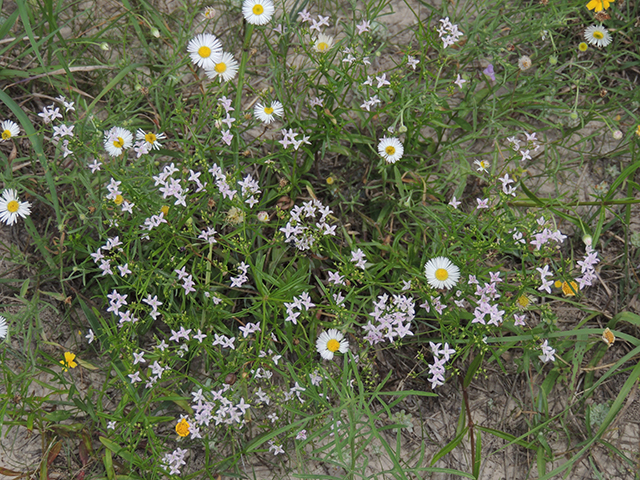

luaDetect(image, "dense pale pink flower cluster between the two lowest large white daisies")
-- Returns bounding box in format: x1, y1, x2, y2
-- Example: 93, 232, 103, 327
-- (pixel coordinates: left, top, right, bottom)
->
362, 293, 416, 345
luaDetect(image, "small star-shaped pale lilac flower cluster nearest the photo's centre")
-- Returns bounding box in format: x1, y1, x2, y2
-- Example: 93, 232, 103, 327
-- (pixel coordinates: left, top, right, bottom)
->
280, 199, 337, 251
